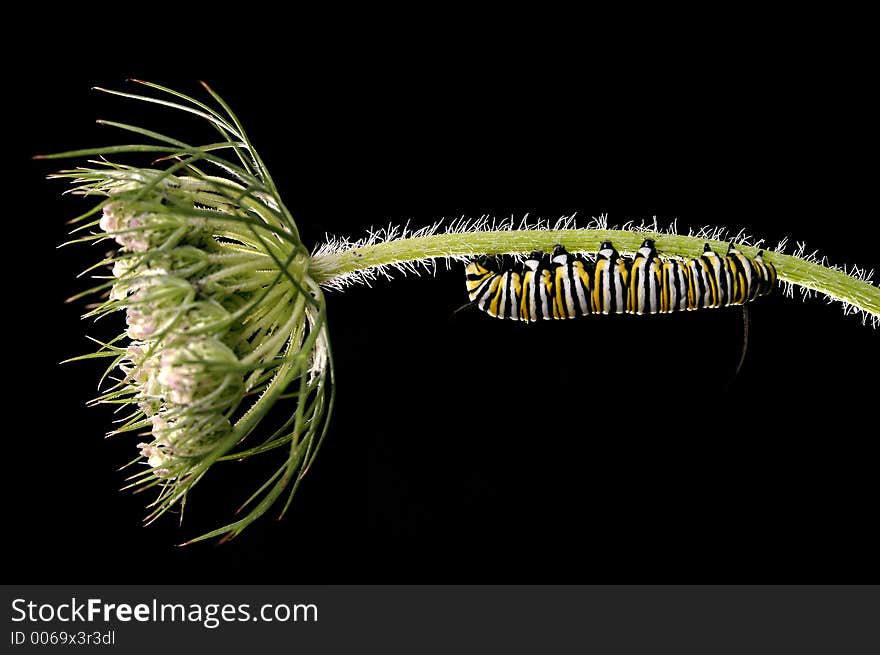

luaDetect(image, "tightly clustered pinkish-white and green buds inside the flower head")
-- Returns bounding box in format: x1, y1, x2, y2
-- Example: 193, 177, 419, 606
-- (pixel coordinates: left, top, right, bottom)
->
99, 200, 248, 480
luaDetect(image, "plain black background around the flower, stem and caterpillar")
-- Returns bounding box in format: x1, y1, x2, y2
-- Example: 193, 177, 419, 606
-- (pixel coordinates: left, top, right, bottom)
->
4, 35, 880, 583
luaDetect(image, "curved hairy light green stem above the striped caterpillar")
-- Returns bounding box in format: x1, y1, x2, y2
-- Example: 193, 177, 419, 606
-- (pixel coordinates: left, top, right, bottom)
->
310, 229, 880, 317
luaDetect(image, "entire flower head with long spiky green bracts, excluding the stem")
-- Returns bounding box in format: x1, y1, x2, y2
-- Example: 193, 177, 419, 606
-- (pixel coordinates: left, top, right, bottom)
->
47, 83, 333, 543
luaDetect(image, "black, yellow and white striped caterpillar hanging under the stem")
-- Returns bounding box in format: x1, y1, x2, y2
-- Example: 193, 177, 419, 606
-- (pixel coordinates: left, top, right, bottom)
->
465, 239, 776, 322
